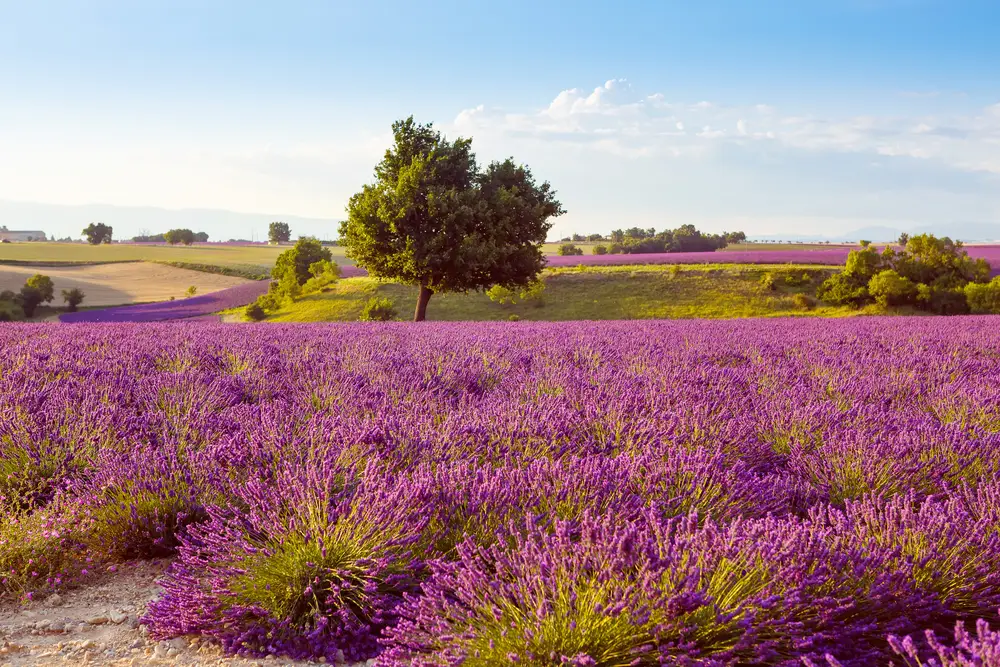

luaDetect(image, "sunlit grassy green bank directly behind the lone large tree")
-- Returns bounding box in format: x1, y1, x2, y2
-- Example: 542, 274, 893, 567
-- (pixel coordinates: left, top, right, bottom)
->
254, 264, 904, 322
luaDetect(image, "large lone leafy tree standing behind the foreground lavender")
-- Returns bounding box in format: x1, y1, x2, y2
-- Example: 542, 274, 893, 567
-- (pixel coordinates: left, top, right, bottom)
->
340, 116, 563, 322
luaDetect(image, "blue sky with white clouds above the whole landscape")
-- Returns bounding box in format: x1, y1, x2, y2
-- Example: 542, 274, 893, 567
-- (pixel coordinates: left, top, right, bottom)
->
0, 0, 1000, 238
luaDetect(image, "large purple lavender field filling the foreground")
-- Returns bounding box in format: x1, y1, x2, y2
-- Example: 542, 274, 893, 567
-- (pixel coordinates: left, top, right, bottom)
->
0, 317, 1000, 666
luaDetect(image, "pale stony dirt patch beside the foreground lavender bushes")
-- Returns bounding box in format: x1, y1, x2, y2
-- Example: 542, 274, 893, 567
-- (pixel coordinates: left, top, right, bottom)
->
0, 562, 366, 667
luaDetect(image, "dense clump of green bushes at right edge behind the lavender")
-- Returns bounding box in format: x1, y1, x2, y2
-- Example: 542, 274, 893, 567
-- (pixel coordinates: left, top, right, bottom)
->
817, 234, 1000, 315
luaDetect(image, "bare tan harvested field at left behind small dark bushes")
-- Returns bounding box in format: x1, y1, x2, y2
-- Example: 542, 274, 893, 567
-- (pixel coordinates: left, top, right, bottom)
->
0, 262, 250, 306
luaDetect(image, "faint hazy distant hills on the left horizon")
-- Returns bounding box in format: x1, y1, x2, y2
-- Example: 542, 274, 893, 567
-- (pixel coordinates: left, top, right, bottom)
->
0, 200, 339, 241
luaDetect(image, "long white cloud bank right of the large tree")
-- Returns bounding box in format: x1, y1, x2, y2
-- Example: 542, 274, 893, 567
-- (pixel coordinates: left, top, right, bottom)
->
455, 79, 1000, 174
